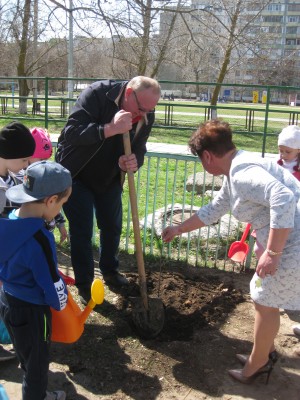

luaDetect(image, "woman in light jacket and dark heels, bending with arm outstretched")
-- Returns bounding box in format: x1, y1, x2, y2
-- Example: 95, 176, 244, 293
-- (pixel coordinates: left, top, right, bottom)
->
163, 120, 300, 383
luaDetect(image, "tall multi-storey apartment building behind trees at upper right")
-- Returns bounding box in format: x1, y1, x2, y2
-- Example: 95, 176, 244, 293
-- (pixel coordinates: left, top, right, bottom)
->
159, 0, 300, 86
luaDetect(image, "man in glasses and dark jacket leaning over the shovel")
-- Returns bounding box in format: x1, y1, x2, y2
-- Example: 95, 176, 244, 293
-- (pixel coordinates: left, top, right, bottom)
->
56, 76, 160, 303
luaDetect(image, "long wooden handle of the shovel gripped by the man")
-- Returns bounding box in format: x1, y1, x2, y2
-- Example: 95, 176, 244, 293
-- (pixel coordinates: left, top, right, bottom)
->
123, 132, 148, 310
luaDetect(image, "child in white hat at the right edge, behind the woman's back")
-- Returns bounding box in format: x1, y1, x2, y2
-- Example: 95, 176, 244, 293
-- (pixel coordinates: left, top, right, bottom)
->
277, 125, 300, 336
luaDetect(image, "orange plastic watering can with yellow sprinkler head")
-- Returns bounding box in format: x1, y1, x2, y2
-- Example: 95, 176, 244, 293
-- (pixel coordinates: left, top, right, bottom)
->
51, 279, 104, 343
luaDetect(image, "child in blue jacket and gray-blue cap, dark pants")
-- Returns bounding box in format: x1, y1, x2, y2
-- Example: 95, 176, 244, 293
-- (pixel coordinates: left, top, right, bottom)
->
0, 161, 72, 400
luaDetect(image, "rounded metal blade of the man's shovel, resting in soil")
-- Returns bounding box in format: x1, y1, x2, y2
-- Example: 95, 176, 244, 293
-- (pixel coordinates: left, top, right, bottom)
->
130, 297, 165, 339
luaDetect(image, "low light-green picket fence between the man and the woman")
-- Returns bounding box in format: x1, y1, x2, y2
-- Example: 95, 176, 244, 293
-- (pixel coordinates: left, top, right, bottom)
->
48, 136, 256, 270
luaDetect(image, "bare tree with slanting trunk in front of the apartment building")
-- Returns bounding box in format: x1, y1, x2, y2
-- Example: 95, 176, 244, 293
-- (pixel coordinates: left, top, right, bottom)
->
166, 0, 271, 105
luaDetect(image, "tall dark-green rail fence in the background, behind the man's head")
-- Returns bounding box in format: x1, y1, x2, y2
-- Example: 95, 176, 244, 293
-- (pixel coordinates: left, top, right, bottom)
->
0, 77, 299, 155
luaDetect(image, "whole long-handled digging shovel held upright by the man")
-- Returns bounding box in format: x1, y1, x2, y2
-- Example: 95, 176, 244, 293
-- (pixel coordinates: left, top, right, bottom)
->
123, 132, 165, 339
